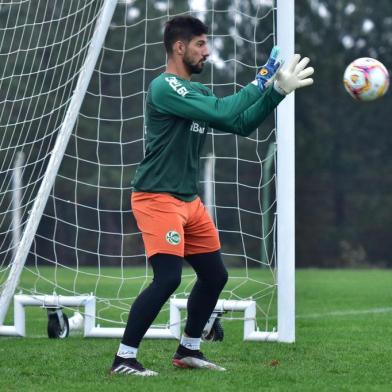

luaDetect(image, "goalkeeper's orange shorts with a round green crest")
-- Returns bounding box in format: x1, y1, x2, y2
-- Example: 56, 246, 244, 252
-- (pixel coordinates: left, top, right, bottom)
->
131, 192, 221, 257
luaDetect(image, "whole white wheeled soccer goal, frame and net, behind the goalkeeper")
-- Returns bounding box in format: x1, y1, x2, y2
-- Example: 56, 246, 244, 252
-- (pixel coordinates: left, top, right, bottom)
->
0, 0, 295, 343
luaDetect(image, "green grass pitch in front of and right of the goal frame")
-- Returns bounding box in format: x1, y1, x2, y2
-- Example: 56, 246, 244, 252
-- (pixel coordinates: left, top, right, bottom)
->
0, 270, 392, 392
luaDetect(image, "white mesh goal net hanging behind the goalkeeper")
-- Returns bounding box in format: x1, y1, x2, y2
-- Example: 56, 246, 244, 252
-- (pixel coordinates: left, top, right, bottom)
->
0, 0, 294, 341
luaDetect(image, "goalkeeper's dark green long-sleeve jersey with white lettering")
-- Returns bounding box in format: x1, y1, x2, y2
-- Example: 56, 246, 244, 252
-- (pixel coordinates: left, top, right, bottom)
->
132, 73, 284, 201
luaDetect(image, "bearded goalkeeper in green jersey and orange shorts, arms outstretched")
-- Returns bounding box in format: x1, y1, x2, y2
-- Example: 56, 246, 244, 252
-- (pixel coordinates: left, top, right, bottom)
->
111, 16, 313, 376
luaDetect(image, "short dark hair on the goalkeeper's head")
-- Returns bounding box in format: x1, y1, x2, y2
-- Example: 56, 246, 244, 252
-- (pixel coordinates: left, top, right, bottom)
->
163, 15, 208, 54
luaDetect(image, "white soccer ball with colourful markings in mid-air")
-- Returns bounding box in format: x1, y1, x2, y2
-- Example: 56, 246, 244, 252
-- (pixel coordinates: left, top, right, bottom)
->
343, 57, 389, 101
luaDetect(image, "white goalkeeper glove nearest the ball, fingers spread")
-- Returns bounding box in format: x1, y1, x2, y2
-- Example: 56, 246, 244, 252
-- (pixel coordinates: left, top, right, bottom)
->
274, 54, 314, 95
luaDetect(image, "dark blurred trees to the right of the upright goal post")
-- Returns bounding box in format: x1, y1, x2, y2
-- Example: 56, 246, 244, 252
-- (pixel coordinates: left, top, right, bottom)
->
296, 0, 392, 266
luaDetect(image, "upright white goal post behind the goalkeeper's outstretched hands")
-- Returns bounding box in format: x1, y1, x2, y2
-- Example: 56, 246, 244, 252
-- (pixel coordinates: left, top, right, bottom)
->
276, 0, 295, 343
